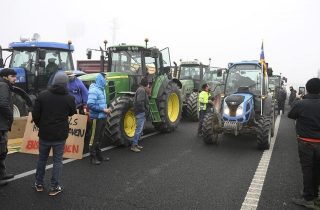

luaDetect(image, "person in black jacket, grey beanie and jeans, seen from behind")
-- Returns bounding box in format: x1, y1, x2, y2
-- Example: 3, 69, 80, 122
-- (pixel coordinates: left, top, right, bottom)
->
32, 71, 77, 196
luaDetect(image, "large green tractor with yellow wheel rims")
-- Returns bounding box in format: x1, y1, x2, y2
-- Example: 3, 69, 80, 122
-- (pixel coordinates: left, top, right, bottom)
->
79, 40, 182, 146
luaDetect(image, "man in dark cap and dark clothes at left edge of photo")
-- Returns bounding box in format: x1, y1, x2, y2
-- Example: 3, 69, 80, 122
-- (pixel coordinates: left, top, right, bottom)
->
0, 68, 17, 186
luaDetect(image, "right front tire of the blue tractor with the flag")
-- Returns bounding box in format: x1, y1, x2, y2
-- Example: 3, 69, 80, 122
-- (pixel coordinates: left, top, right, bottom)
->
257, 116, 272, 150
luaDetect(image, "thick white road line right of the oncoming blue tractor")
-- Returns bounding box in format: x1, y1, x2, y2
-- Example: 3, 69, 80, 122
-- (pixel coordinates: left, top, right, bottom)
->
241, 115, 281, 210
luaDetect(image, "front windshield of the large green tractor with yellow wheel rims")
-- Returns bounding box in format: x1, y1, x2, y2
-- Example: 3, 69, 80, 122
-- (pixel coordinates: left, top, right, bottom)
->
111, 51, 141, 74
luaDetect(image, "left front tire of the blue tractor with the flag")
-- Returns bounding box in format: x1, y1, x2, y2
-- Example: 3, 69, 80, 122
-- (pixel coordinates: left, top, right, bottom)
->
202, 112, 219, 145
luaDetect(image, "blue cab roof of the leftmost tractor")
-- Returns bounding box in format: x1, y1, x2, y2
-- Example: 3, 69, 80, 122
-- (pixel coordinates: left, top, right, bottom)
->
9, 42, 74, 51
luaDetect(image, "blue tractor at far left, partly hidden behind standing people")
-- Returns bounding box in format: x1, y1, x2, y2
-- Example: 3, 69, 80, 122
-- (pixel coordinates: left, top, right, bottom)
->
0, 40, 81, 117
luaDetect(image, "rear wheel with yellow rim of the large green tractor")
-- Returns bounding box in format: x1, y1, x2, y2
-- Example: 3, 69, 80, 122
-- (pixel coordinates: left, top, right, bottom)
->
153, 82, 182, 132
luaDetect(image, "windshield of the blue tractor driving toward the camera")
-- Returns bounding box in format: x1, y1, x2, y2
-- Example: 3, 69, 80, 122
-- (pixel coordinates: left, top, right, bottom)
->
225, 64, 261, 95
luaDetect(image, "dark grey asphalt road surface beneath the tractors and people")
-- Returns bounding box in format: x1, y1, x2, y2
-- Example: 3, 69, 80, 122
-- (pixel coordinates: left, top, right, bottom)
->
0, 116, 303, 210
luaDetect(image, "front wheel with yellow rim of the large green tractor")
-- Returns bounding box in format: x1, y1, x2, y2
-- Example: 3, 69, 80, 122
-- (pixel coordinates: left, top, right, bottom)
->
105, 96, 135, 146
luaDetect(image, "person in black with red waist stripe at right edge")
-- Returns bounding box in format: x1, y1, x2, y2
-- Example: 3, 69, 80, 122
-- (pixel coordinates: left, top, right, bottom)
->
288, 78, 320, 208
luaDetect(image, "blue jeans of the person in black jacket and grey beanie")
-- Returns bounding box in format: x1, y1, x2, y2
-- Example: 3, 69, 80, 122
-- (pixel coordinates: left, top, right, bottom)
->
36, 139, 66, 187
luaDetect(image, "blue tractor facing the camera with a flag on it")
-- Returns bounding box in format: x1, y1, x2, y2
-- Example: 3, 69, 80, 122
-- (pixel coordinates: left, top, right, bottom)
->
203, 61, 275, 150
